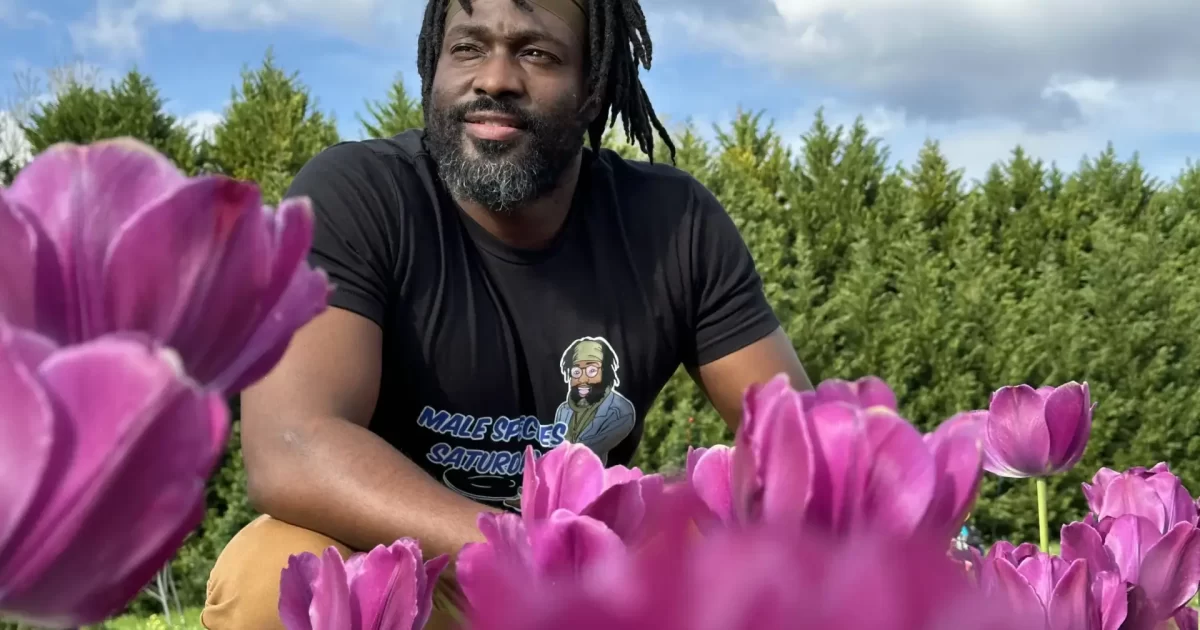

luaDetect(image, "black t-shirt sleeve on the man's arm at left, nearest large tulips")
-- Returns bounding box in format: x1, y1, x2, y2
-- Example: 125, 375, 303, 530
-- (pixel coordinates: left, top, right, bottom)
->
286, 143, 398, 328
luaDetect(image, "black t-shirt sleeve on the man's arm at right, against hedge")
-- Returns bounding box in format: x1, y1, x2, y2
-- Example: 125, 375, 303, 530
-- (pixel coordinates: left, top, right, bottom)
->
689, 177, 779, 366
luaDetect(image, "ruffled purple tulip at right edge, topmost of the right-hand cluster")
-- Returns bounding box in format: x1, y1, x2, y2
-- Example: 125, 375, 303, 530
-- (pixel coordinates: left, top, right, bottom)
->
1084, 462, 1198, 534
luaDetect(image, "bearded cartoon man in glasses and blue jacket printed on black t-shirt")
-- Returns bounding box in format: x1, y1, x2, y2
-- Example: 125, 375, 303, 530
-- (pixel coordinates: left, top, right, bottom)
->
554, 337, 637, 461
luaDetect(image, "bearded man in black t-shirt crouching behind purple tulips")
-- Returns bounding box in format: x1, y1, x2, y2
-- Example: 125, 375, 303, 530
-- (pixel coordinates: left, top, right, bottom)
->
203, 0, 809, 630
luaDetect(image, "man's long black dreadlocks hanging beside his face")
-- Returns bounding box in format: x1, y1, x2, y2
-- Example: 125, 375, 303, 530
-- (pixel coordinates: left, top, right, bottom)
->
416, 0, 676, 163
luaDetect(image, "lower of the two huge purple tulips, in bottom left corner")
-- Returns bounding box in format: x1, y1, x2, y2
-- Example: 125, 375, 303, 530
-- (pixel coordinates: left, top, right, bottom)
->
0, 322, 229, 628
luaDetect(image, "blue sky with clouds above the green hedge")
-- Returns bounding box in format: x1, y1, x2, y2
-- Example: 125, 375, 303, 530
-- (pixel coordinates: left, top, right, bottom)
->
0, 0, 1200, 178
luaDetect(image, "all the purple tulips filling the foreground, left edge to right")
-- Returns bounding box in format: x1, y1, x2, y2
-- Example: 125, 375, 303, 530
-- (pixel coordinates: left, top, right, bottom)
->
0, 140, 1200, 630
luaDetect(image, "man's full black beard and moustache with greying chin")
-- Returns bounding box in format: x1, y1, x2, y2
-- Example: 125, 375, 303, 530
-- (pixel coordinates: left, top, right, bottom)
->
425, 92, 583, 212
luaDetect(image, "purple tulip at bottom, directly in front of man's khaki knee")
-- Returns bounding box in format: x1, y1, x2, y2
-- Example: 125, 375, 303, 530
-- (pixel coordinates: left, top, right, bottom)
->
280, 539, 450, 630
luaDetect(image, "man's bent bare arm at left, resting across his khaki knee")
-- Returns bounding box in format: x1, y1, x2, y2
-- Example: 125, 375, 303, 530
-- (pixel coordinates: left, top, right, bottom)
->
241, 308, 487, 558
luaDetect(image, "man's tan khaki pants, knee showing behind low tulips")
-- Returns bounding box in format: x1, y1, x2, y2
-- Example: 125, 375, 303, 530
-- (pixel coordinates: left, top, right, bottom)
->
200, 516, 457, 630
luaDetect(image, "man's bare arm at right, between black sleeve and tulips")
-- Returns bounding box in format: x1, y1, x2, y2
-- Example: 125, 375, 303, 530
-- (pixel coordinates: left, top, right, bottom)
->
689, 328, 812, 431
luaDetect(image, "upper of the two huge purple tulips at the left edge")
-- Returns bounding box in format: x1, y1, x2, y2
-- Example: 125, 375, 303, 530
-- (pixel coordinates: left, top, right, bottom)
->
0, 139, 329, 394
